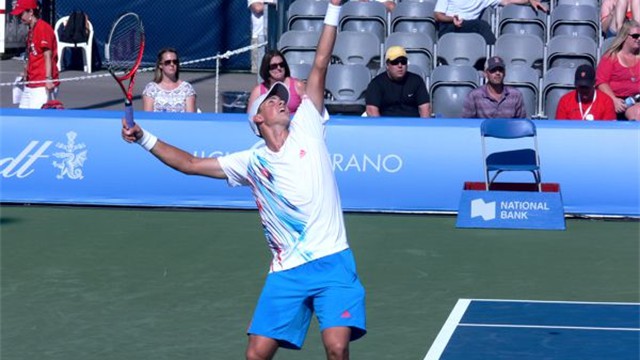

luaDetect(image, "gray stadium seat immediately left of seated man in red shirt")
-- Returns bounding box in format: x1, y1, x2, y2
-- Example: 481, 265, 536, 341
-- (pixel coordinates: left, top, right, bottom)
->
542, 67, 576, 119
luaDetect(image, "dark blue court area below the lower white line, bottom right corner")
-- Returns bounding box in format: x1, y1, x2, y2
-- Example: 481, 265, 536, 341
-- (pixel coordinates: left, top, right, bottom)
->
440, 326, 640, 360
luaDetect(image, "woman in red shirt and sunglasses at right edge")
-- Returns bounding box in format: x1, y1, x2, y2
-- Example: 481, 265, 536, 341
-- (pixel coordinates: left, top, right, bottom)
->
596, 20, 640, 120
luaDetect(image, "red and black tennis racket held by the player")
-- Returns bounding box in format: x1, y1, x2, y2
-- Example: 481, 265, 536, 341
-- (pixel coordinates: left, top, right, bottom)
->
106, 13, 144, 128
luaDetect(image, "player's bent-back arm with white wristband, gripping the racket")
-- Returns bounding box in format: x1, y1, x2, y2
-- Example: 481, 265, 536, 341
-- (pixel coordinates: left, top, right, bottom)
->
122, 119, 227, 179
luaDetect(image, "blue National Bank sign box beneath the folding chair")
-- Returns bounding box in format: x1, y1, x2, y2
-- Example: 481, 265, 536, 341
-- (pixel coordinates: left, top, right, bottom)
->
456, 190, 565, 230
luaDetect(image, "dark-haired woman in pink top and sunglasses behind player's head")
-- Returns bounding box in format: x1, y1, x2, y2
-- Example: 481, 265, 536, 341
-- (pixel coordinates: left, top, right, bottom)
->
247, 50, 305, 116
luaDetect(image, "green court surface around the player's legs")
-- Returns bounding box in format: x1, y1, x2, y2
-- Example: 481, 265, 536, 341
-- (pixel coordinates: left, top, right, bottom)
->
0, 206, 640, 360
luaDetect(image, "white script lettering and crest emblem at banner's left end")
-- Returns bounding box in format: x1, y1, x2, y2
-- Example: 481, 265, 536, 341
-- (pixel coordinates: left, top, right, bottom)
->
0, 131, 88, 180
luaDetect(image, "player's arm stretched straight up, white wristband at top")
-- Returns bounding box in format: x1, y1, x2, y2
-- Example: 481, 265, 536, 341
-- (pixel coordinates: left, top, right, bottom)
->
306, 0, 341, 112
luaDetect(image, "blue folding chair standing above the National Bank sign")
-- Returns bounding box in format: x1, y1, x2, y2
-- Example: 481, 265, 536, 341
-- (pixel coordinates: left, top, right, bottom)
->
480, 119, 542, 191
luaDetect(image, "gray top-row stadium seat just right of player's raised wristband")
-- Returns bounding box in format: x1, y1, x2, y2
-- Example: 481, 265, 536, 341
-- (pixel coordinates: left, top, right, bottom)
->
338, 1, 388, 43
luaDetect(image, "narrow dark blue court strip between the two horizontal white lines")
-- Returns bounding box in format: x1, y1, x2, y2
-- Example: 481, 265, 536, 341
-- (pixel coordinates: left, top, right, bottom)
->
460, 301, 640, 330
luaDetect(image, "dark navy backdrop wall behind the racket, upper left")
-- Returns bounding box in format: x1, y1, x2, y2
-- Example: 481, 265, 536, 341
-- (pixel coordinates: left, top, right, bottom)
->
52, 0, 251, 70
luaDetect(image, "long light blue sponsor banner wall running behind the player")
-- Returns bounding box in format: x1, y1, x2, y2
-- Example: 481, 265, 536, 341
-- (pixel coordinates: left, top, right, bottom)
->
0, 109, 640, 217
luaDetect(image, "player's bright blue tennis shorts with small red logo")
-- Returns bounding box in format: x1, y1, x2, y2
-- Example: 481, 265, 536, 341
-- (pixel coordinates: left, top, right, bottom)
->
248, 249, 367, 349
